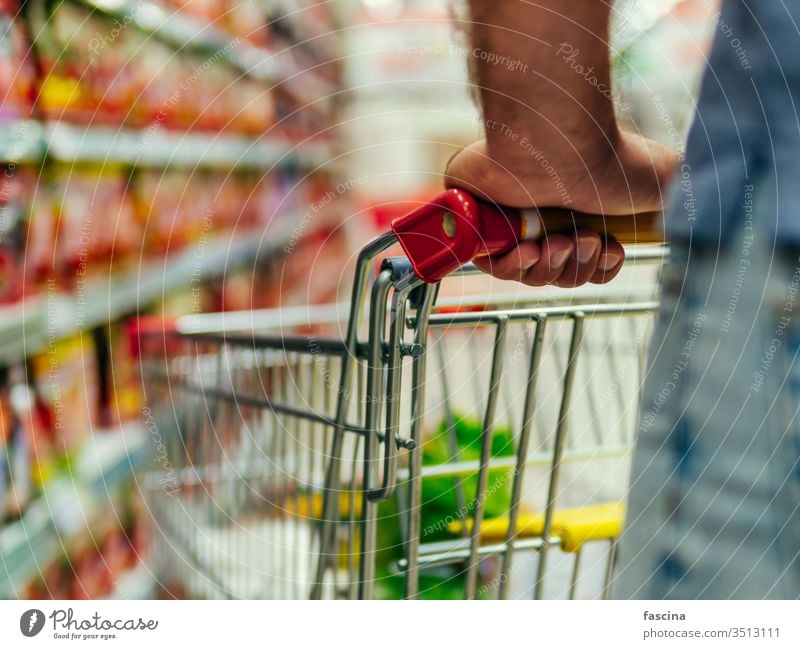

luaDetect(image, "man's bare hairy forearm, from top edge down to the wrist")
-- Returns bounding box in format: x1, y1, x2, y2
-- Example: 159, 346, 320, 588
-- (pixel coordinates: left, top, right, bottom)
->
469, 0, 617, 169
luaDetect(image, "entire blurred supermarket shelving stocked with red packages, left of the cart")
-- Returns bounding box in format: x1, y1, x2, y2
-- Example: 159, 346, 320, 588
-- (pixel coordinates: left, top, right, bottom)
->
0, 0, 341, 598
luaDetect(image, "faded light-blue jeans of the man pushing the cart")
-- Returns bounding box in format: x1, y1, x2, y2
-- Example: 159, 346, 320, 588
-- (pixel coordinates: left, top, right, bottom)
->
612, 178, 800, 599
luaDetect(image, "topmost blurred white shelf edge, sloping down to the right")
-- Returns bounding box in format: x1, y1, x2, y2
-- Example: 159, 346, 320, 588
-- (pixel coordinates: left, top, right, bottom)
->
73, 0, 335, 105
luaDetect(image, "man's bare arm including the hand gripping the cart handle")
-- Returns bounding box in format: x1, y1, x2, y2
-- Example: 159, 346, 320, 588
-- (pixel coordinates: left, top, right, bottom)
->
446, 0, 678, 286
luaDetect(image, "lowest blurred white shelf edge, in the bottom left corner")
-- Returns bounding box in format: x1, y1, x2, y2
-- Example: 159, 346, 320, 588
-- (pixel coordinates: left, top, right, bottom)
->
0, 423, 148, 598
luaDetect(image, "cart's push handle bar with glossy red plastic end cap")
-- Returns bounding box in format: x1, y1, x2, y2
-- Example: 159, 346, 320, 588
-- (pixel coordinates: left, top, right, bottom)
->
392, 189, 664, 283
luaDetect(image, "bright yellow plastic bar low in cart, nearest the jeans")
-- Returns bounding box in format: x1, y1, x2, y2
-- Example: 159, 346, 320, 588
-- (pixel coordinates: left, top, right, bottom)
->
448, 502, 625, 552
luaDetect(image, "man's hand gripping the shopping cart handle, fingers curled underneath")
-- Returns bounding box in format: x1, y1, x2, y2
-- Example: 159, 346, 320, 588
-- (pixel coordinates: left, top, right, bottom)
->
445, 133, 679, 287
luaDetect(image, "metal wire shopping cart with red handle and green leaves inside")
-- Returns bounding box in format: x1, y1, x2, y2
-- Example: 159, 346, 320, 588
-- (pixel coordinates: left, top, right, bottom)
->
139, 190, 663, 598
